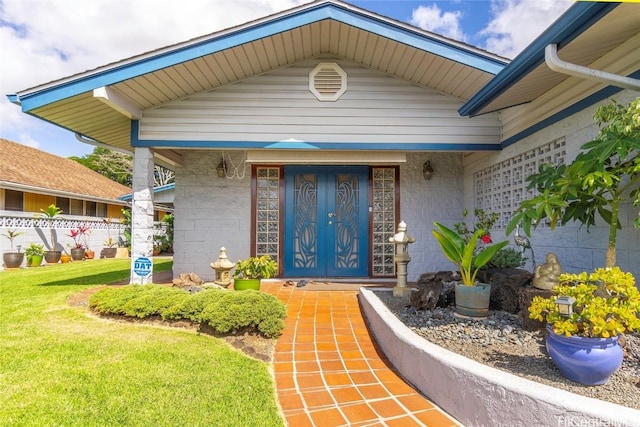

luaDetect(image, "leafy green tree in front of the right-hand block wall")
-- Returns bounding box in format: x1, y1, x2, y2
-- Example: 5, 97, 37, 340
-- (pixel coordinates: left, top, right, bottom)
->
506, 98, 640, 267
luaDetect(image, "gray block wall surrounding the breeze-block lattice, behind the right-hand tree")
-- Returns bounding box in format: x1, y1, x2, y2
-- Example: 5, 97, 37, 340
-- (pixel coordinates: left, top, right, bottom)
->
464, 91, 640, 277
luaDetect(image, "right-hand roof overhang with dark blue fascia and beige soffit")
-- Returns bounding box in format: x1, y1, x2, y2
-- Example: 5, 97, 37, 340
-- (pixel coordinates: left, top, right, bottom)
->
458, 2, 640, 116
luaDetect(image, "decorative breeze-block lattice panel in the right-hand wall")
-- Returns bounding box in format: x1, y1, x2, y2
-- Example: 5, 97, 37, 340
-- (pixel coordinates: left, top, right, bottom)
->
474, 138, 566, 229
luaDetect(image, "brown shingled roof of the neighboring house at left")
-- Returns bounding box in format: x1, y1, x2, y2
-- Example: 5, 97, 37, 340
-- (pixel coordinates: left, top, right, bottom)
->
0, 138, 131, 205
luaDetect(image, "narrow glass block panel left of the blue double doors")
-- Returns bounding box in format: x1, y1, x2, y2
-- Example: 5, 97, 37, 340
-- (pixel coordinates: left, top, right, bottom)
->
256, 167, 280, 260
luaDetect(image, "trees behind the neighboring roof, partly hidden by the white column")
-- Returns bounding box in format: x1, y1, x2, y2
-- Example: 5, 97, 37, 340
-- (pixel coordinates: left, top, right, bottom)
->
69, 147, 175, 187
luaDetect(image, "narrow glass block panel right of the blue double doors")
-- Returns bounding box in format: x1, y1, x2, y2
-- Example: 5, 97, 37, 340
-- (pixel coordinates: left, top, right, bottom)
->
371, 168, 396, 276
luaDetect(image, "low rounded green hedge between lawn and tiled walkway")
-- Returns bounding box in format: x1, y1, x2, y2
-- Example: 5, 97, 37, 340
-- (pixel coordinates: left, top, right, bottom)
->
89, 285, 286, 338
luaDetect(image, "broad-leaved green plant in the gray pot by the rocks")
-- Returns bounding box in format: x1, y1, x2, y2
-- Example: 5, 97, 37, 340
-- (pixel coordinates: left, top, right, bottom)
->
431, 222, 509, 286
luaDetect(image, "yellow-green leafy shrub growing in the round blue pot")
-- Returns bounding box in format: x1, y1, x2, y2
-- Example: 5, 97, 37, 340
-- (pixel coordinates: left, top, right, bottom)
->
529, 267, 640, 338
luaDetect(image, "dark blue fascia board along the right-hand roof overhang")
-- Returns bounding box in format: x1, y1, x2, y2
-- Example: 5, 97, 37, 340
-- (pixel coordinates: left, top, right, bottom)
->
458, 1, 619, 116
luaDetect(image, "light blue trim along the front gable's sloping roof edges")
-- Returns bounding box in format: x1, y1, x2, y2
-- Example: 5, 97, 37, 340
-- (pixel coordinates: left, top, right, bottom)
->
15, 3, 506, 112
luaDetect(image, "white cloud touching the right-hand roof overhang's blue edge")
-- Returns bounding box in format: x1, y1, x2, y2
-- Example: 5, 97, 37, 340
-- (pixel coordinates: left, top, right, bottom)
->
481, 0, 573, 58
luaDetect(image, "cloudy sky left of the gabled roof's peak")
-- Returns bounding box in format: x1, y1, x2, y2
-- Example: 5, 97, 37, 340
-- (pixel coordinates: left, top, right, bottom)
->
0, 0, 309, 154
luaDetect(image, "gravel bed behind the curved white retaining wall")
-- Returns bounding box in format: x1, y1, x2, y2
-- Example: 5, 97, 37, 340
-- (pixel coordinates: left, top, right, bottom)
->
374, 292, 640, 409
